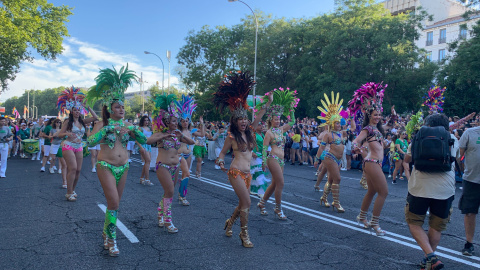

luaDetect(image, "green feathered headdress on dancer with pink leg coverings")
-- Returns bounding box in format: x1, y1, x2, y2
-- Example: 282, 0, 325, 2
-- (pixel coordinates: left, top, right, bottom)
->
153, 93, 179, 132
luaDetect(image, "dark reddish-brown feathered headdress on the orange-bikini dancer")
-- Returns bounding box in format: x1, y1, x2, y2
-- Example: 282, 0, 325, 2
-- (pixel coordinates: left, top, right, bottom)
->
213, 71, 255, 118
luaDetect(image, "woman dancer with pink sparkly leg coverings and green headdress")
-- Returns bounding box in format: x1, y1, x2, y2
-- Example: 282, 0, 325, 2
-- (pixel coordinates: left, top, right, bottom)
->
147, 94, 194, 233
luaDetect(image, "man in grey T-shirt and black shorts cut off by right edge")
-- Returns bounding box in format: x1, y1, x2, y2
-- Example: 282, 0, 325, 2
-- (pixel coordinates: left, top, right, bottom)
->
458, 121, 480, 256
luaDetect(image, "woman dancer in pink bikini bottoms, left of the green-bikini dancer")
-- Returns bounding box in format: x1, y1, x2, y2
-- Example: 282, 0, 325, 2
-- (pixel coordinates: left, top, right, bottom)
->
57, 86, 98, 202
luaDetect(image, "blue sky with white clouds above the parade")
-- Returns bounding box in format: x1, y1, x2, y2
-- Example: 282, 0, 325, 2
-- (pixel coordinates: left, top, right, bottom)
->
0, 0, 334, 102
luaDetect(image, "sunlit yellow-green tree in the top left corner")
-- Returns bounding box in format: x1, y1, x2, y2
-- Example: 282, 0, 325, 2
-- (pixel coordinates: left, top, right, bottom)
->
0, 0, 72, 91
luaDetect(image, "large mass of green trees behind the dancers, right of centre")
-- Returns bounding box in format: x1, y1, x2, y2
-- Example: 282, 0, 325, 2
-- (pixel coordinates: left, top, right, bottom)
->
178, 0, 438, 117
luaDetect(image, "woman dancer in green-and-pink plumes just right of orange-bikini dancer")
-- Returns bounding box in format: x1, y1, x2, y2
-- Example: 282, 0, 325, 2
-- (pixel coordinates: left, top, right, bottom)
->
257, 88, 296, 220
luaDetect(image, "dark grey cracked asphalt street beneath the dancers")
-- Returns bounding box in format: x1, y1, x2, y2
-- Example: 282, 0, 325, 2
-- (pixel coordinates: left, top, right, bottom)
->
0, 155, 480, 269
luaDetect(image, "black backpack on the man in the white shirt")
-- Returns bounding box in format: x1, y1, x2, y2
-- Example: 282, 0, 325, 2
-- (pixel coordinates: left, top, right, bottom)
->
412, 126, 455, 172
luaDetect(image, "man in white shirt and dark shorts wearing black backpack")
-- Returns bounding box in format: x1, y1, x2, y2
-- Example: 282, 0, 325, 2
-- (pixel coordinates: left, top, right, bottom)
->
405, 114, 455, 270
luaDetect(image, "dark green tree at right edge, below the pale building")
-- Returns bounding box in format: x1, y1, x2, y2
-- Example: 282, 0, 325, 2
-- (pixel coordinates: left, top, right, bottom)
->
437, 19, 480, 117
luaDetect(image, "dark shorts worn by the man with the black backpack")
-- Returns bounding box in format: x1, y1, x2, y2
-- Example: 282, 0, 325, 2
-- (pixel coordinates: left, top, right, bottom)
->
405, 193, 455, 232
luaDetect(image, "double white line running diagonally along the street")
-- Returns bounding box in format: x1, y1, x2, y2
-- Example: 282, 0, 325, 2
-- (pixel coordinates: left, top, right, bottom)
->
191, 176, 480, 268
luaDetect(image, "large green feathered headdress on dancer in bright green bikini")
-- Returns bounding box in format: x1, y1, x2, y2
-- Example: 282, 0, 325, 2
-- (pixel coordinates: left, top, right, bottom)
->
87, 63, 138, 112
